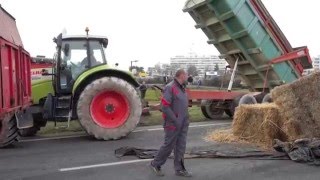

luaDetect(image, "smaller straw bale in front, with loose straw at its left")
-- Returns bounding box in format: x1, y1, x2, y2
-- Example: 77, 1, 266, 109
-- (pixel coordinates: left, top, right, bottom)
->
232, 103, 286, 146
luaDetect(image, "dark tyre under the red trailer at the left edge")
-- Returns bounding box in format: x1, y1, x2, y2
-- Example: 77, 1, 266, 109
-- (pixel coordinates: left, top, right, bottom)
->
0, 114, 19, 148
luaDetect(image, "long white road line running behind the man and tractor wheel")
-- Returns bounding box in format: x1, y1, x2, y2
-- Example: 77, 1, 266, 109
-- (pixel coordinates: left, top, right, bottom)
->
19, 122, 231, 142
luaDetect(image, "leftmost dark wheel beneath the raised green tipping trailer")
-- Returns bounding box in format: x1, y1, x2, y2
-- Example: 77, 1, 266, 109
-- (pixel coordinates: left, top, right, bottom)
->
201, 100, 224, 119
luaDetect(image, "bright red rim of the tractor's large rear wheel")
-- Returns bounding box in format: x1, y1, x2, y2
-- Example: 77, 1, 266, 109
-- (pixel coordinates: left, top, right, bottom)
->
90, 91, 130, 128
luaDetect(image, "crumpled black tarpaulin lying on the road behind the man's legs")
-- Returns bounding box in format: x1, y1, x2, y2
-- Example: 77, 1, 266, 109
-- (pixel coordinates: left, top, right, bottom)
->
115, 139, 320, 166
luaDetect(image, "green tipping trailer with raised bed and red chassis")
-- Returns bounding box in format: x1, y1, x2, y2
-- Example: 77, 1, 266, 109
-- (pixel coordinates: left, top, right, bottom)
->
183, 0, 312, 119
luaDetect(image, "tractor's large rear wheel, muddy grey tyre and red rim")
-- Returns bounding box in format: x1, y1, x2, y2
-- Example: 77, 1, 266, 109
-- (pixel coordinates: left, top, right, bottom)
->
77, 77, 142, 140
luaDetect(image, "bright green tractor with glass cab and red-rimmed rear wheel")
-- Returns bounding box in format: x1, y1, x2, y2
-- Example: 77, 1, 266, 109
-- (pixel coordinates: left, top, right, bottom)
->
21, 29, 142, 140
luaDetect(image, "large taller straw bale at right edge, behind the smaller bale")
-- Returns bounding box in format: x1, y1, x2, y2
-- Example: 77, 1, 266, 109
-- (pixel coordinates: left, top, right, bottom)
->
271, 72, 320, 140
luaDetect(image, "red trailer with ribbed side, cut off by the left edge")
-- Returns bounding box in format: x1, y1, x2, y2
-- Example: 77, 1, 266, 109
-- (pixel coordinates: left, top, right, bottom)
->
0, 6, 33, 147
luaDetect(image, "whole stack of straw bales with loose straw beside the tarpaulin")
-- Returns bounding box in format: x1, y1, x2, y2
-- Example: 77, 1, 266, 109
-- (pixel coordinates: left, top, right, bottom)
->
208, 72, 320, 147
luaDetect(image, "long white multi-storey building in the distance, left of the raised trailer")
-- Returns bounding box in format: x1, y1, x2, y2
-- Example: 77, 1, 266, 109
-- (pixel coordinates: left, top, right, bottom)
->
170, 54, 228, 77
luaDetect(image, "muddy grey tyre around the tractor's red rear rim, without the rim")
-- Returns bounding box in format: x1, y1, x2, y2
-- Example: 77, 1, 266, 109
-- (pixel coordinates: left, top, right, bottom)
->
77, 77, 142, 140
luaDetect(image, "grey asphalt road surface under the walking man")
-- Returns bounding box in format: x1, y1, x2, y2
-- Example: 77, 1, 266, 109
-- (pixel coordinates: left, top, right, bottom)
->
0, 121, 320, 180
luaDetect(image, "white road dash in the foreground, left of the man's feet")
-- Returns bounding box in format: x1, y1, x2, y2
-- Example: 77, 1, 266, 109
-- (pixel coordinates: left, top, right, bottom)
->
59, 159, 152, 172
